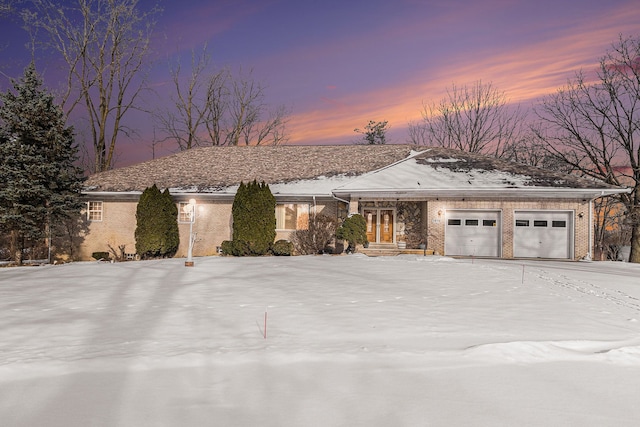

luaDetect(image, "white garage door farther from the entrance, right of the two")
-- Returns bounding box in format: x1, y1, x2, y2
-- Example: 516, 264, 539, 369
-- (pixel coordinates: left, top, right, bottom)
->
513, 211, 573, 259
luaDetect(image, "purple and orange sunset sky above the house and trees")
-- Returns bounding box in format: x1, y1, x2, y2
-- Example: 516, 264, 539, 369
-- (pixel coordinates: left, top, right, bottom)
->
0, 0, 640, 166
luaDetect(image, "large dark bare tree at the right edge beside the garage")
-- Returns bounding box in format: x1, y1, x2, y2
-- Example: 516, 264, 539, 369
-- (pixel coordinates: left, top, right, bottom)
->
537, 36, 640, 262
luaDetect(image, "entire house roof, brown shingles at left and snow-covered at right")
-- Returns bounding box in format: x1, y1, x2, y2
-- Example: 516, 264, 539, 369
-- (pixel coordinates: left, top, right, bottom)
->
85, 145, 619, 198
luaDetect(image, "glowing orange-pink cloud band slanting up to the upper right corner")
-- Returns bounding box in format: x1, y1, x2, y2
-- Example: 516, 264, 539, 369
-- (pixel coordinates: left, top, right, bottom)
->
274, 3, 640, 142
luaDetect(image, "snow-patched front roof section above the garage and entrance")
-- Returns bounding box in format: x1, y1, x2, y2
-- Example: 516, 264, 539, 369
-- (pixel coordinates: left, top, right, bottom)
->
334, 147, 618, 197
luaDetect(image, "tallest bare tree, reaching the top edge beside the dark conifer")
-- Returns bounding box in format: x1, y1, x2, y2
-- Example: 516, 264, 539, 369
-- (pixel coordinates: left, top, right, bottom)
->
23, 0, 158, 172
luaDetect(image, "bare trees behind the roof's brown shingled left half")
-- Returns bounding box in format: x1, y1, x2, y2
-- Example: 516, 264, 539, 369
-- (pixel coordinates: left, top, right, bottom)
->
154, 46, 288, 150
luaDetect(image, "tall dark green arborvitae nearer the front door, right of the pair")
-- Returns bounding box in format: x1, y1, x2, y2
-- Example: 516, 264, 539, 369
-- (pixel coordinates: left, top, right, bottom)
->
232, 181, 276, 255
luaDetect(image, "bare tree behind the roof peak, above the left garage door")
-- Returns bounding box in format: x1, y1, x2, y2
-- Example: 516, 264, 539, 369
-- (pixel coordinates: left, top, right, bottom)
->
409, 81, 524, 157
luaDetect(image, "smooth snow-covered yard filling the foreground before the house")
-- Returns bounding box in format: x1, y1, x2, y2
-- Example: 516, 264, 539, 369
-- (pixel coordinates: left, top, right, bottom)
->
0, 254, 640, 426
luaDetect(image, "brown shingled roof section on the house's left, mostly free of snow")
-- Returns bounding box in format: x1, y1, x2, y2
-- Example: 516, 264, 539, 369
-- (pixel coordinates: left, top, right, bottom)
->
85, 145, 424, 192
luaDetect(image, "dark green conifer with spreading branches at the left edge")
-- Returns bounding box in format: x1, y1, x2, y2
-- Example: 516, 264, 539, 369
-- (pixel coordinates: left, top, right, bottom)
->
0, 63, 83, 264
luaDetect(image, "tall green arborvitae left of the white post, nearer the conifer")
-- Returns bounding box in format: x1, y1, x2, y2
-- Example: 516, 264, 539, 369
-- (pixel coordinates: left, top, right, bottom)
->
135, 184, 180, 259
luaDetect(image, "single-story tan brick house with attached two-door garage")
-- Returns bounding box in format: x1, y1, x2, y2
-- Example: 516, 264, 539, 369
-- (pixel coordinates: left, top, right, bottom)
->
80, 145, 628, 260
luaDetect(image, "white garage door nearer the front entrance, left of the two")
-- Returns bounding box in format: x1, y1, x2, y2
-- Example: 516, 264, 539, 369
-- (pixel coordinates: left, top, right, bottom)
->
444, 210, 501, 257
